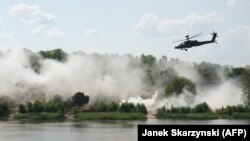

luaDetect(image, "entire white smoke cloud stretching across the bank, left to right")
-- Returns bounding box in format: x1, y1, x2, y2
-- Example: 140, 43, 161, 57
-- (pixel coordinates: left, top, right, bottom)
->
0, 49, 243, 113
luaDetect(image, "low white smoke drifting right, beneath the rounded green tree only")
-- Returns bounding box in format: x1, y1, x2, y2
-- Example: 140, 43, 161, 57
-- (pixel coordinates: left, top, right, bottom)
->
126, 80, 243, 113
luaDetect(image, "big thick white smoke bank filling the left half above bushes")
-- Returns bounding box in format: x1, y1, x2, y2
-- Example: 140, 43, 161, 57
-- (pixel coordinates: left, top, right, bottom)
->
0, 50, 143, 102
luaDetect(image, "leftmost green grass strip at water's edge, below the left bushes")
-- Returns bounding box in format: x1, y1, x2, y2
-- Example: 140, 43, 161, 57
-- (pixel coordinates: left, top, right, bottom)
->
13, 112, 64, 121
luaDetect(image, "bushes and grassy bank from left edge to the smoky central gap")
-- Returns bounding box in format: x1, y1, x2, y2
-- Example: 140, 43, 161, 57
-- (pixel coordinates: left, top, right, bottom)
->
0, 92, 147, 120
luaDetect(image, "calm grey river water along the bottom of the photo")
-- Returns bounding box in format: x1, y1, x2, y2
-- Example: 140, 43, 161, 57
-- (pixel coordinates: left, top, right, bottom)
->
0, 119, 250, 141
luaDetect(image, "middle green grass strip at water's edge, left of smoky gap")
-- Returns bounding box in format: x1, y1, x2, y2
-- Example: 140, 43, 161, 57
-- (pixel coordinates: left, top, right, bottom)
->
75, 112, 147, 121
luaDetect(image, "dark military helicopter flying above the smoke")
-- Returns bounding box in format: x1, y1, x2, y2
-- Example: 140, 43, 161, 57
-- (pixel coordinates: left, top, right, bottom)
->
175, 32, 218, 51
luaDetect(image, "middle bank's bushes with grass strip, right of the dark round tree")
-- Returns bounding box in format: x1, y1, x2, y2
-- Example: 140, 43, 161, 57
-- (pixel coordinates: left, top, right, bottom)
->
74, 100, 147, 121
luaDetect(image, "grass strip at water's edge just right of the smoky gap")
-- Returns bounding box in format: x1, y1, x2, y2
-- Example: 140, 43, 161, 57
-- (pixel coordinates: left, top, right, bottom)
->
157, 113, 218, 120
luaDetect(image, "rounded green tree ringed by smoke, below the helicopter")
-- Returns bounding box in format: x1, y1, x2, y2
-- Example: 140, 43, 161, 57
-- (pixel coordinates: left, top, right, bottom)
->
165, 77, 196, 96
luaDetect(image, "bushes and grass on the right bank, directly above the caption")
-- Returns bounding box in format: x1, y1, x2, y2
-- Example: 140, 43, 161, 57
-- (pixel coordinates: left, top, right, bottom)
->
156, 102, 250, 119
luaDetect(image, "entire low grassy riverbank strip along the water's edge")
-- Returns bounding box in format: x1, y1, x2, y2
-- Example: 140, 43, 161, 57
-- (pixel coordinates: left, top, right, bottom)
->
5, 112, 250, 122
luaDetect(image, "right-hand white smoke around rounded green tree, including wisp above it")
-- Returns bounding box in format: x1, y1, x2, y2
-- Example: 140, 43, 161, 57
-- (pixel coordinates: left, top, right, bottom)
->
126, 61, 244, 113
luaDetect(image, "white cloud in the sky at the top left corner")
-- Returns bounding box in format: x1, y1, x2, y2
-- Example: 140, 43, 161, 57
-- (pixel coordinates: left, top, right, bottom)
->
9, 4, 55, 24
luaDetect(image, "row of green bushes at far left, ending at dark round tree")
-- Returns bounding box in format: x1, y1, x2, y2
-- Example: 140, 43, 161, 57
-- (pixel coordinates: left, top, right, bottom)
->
0, 92, 89, 119
